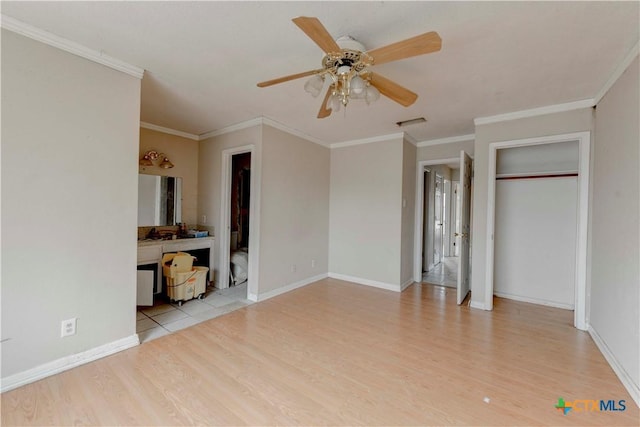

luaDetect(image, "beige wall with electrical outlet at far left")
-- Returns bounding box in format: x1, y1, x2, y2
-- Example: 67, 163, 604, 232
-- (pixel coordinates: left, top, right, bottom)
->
2, 30, 140, 387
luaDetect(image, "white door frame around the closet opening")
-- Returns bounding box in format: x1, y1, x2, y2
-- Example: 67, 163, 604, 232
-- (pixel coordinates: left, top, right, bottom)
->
484, 131, 591, 331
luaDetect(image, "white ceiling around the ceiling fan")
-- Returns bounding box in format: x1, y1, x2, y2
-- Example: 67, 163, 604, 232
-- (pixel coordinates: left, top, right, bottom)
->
2, 1, 640, 143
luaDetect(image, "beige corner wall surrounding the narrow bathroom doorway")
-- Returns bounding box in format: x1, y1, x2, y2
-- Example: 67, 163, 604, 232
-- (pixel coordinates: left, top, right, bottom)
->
198, 125, 329, 299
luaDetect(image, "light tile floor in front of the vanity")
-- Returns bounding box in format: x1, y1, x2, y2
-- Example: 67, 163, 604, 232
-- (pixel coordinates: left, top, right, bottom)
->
136, 282, 253, 342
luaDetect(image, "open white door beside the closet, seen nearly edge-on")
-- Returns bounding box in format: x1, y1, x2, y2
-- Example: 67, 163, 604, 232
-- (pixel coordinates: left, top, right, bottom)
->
458, 151, 471, 304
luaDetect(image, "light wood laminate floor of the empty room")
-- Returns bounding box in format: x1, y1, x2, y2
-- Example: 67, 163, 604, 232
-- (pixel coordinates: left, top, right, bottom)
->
2, 279, 640, 426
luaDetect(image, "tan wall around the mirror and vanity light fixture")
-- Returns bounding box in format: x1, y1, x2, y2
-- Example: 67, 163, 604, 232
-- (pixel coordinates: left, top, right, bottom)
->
138, 128, 198, 226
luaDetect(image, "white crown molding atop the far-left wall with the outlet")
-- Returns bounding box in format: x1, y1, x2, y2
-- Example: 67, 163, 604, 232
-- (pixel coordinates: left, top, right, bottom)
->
0, 15, 144, 79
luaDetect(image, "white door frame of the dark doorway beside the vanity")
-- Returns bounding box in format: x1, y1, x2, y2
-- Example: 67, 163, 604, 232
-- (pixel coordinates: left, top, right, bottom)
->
216, 144, 260, 301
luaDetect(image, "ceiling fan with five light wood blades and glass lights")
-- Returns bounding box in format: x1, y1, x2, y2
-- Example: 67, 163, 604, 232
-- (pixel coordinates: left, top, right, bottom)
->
258, 16, 442, 119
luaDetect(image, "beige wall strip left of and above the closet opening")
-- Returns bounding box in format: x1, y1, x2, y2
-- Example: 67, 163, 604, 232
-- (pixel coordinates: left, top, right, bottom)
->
471, 108, 593, 306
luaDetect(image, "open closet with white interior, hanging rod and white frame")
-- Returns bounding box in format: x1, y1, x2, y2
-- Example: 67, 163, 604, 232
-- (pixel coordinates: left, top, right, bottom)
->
484, 132, 591, 330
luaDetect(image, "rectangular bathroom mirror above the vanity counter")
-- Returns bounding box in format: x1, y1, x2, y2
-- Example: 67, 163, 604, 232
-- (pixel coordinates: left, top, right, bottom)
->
138, 174, 182, 227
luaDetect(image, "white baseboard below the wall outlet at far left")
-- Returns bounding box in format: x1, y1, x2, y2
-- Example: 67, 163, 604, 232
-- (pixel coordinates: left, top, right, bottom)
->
0, 334, 140, 393
